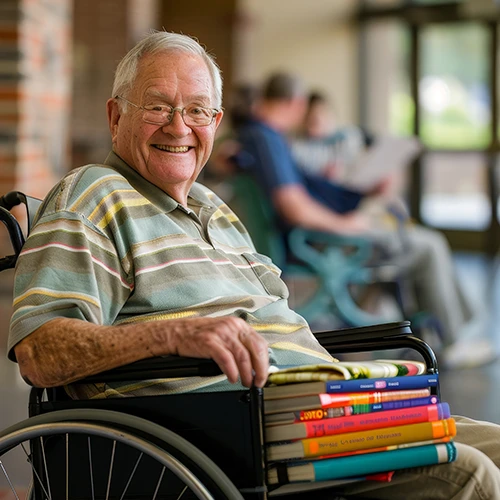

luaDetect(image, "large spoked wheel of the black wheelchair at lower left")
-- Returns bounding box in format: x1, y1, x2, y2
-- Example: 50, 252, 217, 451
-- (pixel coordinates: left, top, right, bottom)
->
0, 409, 243, 500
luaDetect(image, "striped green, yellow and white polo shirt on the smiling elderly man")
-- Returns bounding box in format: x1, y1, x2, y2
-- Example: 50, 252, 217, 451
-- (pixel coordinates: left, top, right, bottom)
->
8, 153, 332, 398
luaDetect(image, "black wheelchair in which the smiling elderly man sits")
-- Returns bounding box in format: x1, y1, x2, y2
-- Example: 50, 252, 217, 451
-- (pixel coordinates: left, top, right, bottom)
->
0, 189, 439, 500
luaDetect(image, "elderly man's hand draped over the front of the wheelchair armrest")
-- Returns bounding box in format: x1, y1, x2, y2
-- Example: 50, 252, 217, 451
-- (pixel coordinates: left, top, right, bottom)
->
156, 317, 269, 387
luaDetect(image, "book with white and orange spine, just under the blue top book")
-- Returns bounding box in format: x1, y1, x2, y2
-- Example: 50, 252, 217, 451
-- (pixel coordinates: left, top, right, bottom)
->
264, 388, 431, 418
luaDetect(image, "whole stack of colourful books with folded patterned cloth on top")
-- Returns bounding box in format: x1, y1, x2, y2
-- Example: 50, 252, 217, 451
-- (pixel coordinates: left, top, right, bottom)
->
264, 360, 456, 492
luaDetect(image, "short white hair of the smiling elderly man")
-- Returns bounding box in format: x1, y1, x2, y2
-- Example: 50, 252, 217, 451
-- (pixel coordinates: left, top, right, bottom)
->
112, 31, 222, 108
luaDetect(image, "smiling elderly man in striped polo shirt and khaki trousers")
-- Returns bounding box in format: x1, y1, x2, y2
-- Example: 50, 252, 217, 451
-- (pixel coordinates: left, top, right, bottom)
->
5, 32, 500, 499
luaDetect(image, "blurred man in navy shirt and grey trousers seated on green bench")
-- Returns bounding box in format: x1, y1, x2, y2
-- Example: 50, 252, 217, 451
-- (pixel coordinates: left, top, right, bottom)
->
238, 73, 497, 368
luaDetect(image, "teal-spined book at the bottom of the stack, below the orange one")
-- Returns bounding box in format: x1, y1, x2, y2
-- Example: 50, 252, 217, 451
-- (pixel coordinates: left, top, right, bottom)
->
268, 442, 457, 484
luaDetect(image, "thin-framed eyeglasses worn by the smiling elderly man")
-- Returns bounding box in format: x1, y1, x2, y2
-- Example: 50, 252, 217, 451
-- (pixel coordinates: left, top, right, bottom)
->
115, 95, 221, 127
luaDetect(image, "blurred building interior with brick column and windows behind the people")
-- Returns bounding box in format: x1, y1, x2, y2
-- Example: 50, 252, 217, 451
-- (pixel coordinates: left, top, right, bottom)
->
0, 0, 500, 448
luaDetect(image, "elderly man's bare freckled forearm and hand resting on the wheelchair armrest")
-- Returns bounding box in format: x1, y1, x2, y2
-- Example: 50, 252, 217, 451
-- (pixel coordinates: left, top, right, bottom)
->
14, 316, 269, 387
